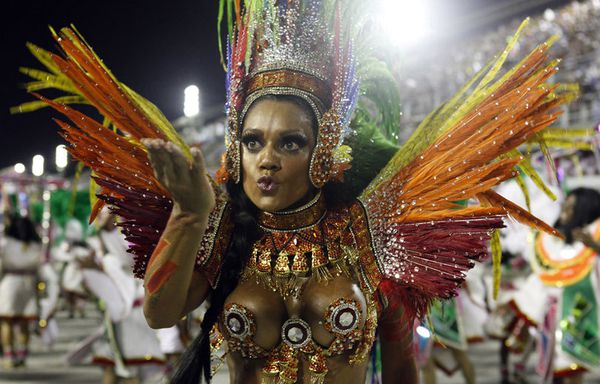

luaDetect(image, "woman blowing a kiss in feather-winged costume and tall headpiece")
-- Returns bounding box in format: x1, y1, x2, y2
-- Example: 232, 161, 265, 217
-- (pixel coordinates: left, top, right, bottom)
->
11, 0, 588, 383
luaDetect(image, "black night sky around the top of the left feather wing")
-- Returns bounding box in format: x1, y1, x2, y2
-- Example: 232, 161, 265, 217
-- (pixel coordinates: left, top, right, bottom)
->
0, 0, 225, 169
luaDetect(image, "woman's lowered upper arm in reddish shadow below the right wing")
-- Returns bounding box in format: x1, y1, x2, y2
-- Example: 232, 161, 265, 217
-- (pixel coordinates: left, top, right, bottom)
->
379, 309, 419, 384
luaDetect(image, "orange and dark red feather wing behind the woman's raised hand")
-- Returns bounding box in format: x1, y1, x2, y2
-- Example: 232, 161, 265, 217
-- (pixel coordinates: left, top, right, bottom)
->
13, 28, 191, 277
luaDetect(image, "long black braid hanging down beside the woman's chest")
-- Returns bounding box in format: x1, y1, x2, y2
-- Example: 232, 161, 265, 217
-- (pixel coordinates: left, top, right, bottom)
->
171, 182, 259, 384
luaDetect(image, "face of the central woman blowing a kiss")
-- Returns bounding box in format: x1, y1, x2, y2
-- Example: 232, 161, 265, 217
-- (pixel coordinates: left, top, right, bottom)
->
242, 99, 315, 212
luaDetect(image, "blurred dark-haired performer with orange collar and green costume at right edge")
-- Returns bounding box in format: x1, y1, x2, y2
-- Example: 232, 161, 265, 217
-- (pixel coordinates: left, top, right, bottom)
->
518, 188, 600, 383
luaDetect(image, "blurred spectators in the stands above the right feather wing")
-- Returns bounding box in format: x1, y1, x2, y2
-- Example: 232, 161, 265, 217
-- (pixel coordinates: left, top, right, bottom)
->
399, 0, 600, 130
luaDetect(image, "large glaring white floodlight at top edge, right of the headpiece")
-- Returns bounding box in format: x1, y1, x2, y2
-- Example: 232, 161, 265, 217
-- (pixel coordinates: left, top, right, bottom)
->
380, 0, 431, 47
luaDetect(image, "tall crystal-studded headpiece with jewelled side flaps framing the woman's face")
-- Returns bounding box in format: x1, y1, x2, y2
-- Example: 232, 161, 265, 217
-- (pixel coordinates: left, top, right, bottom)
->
217, 0, 358, 188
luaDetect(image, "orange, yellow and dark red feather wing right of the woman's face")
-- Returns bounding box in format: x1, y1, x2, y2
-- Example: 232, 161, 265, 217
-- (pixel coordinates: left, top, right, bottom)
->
359, 21, 571, 312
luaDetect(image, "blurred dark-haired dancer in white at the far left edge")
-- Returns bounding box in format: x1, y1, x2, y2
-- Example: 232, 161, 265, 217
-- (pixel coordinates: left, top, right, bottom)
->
0, 217, 42, 368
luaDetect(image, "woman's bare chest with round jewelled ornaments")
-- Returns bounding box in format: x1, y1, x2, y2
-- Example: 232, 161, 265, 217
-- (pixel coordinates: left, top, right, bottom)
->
221, 275, 368, 358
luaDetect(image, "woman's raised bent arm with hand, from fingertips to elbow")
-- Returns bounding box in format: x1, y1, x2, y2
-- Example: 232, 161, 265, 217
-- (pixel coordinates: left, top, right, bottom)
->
143, 140, 215, 328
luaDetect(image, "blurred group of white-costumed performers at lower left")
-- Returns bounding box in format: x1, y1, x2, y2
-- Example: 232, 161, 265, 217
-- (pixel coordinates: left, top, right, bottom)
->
0, 190, 203, 384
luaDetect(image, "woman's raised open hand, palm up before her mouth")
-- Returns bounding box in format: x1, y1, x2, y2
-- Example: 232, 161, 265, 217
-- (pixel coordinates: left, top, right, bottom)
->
141, 139, 215, 217
